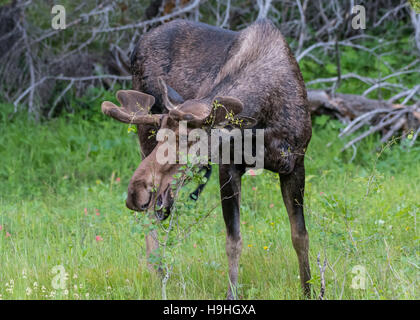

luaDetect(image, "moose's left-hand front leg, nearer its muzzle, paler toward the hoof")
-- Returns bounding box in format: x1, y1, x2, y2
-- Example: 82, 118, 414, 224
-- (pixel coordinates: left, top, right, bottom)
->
219, 165, 244, 300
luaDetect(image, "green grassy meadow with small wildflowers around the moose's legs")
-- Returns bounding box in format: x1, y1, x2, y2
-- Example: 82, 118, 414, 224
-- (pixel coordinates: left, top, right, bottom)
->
0, 102, 420, 299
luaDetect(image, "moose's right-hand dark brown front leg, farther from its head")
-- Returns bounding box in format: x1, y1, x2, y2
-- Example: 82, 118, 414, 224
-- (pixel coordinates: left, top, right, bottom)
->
280, 159, 311, 298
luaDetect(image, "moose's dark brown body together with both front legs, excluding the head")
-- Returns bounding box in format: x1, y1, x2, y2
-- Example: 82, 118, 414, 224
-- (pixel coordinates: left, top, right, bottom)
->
108, 20, 312, 298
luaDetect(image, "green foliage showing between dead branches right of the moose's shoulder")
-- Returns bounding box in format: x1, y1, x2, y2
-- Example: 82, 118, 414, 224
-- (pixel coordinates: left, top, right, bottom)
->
299, 32, 418, 102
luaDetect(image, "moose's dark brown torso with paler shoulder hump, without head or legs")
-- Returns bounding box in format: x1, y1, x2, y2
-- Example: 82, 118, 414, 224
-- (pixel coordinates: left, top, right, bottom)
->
132, 20, 311, 173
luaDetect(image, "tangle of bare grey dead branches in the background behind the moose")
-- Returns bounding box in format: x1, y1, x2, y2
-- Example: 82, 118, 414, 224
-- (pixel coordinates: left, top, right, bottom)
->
0, 0, 420, 139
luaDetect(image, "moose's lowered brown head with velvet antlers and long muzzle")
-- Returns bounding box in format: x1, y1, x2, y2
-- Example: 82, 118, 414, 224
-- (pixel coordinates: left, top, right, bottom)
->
102, 78, 253, 220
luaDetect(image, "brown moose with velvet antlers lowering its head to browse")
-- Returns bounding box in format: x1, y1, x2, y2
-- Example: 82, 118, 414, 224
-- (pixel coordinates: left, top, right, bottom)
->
102, 19, 312, 299
